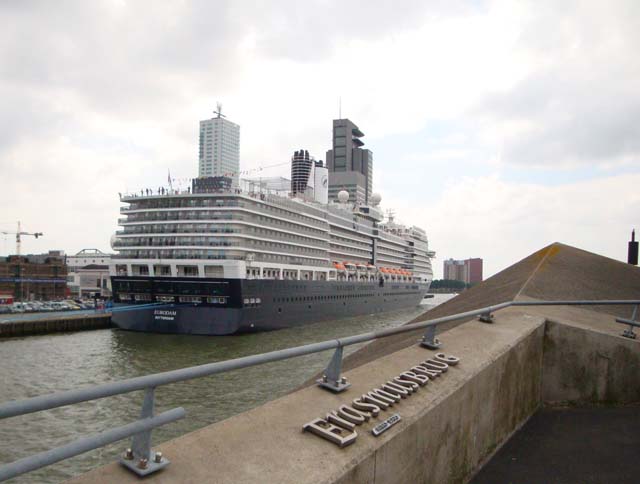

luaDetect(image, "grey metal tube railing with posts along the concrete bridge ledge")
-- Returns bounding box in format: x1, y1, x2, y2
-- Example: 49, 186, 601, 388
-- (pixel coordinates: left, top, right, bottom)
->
0, 300, 640, 481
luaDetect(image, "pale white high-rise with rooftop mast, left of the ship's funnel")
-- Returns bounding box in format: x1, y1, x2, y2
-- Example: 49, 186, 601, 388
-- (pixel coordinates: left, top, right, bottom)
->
198, 105, 240, 186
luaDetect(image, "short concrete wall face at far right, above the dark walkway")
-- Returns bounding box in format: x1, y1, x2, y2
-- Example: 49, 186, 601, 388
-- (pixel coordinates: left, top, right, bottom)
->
542, 318, 640, 405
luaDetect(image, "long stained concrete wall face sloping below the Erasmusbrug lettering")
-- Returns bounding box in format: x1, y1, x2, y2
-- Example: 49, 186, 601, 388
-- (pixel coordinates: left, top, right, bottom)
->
368, 327, 543, 484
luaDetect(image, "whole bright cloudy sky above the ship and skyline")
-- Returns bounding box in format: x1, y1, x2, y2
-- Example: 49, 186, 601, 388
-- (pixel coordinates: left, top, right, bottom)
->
0, 0, 640, 278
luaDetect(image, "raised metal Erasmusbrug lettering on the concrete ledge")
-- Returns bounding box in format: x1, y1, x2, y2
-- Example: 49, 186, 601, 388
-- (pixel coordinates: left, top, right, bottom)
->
302, 353, 460, 447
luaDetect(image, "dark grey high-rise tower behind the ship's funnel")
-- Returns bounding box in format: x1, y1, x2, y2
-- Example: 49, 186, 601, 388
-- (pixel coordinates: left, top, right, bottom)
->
327, 119, 373, 204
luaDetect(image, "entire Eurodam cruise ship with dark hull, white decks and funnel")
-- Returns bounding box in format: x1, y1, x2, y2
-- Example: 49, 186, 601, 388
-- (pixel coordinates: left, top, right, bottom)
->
110, 120, 435, 335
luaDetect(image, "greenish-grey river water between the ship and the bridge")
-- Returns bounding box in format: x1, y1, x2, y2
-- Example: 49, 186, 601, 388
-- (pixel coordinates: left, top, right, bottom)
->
0, 294, 451, 483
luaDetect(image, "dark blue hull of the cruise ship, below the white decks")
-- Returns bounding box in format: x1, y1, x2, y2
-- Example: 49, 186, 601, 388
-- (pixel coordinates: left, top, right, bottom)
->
112, 277, 429, 335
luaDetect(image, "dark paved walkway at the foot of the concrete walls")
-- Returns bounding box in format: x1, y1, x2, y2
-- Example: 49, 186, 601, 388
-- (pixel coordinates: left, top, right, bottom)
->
471, 406, 640, 484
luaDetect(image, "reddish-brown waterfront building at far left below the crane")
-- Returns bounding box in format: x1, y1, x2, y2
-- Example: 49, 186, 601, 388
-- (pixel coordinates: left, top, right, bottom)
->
0, 251, 67, 301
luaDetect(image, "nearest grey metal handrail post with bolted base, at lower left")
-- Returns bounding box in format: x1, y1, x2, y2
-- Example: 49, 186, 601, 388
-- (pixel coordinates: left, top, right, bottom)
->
120, 387, 170, 476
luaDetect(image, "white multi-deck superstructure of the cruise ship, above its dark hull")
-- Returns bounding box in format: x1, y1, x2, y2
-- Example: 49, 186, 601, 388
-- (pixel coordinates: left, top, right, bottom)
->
111, 183, 433, 292
